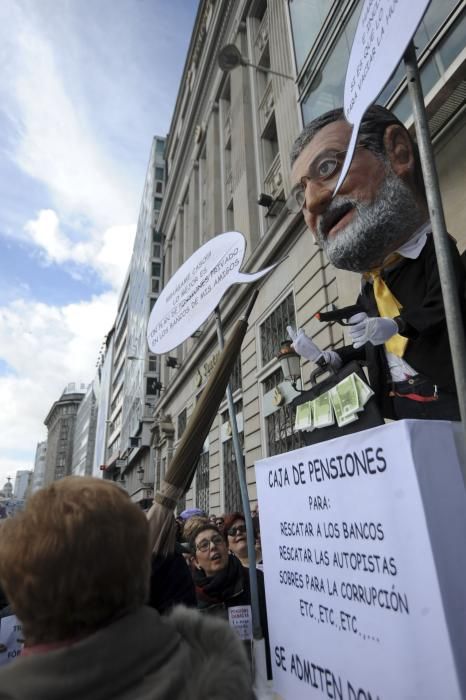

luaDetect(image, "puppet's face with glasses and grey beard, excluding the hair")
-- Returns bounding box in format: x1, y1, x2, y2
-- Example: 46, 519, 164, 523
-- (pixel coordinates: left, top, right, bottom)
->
291, 121, 421, 272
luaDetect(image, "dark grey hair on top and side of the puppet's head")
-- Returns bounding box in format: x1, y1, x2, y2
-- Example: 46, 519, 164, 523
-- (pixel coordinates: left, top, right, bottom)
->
290, 105, 425, 199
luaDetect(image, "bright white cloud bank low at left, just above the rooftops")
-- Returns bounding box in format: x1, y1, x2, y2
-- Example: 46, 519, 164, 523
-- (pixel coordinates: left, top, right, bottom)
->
0, 293, 117, 484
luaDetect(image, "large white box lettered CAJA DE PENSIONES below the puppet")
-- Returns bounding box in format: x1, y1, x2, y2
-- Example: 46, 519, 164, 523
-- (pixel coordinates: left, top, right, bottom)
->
256, 421, 466, 700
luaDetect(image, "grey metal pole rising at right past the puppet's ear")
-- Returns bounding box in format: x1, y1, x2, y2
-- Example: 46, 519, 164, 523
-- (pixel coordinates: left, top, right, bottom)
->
404, 41, 466, 484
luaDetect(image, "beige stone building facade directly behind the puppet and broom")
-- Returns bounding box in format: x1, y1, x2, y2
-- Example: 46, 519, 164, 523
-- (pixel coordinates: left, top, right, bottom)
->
152, 0, 466, 513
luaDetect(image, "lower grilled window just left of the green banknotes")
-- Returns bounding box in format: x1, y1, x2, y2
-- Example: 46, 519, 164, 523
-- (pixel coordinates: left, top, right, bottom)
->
262, 368, 305, 456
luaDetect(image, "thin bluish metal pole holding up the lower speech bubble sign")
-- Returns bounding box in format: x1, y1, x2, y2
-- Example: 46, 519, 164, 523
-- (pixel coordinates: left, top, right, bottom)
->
215, 306, 263, 639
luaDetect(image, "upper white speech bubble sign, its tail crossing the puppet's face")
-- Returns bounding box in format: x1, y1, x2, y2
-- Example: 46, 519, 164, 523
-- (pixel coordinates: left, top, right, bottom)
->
333, 0, 430, 196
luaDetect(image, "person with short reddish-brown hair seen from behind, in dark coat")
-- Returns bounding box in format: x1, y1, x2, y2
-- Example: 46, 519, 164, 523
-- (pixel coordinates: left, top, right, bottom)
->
0, 477, 253, 700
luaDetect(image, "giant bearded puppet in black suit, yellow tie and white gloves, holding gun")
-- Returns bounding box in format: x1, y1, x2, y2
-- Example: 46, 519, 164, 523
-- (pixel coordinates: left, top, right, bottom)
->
288, 105, 466, 420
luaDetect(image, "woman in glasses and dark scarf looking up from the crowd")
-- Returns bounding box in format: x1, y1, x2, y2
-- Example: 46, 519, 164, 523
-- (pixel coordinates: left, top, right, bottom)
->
190, 521, 272, 678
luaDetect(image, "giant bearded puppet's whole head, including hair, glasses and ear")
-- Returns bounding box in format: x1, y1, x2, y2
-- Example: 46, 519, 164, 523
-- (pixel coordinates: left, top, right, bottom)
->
290, 105, 428, 272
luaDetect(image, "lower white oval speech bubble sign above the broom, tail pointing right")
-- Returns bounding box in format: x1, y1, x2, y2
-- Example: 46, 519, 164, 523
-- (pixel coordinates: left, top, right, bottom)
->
147, 231, 275, 355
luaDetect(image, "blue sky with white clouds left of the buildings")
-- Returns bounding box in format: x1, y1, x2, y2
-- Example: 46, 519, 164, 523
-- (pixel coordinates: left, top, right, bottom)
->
0, 0, 198, 486
